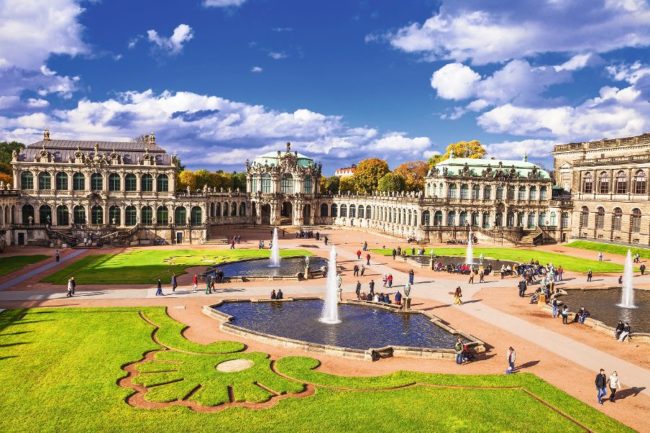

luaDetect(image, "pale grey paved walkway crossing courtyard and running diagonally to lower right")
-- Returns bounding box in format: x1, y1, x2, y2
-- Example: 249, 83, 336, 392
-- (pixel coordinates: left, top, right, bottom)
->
0, 249, 650, 395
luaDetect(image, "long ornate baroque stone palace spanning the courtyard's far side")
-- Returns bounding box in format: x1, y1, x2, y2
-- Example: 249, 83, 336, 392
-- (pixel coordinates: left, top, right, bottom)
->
0, 131, 650, 246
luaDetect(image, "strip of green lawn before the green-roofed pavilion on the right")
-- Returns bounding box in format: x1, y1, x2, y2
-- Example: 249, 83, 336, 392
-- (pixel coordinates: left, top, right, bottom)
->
372, 247, 623, 273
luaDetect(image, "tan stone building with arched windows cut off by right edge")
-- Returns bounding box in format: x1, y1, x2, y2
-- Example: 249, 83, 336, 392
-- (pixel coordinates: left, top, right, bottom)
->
553, 134, 650, 245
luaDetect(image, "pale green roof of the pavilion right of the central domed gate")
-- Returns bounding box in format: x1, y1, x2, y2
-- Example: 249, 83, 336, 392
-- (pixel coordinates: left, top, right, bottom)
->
436, 158, 551, 179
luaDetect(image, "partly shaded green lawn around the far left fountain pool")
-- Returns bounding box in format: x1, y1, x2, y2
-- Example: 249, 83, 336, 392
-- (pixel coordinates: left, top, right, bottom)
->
42, 249, 311, 284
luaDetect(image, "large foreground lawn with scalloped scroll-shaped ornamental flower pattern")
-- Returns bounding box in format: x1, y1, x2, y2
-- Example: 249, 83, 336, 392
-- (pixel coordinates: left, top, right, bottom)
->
0, 307, 632, 433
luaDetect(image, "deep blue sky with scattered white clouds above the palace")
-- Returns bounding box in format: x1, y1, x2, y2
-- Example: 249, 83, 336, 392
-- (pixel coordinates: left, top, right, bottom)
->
0, 0, 650, 173
